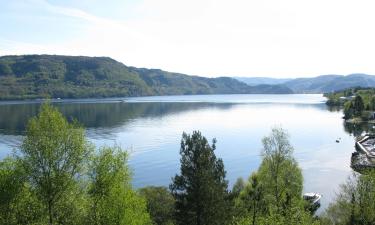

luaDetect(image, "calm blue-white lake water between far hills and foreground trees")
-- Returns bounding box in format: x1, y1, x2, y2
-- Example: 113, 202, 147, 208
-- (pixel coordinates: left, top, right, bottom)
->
0, 95, 354, 211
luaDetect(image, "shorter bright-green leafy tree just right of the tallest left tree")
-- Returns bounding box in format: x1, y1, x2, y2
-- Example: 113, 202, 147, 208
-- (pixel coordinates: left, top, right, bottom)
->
88, 147, 151, 225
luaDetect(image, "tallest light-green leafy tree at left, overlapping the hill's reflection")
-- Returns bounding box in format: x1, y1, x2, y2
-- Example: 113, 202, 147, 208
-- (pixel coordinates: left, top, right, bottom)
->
20, 103, 91, 225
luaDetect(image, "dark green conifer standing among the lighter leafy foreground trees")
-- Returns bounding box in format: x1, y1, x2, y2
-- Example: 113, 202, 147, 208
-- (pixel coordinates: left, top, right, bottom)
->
170, 131, 230, 225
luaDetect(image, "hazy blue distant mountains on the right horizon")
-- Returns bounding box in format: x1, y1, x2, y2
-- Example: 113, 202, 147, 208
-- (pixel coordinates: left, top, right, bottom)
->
283, 74, 375, 93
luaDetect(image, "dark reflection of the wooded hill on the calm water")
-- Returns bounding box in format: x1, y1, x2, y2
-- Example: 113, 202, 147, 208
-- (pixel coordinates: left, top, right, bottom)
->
0, 102, 233, 135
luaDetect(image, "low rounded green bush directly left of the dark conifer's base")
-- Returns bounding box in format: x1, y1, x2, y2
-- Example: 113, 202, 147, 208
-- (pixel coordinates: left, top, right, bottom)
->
139, 186, 175, 225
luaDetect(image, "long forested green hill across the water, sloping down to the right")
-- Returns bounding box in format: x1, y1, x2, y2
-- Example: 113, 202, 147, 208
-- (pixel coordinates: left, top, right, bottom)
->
0, 55, 292, 100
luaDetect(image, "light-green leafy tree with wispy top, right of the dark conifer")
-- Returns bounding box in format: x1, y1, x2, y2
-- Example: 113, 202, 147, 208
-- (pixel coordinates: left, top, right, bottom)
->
232, 128, 317, 225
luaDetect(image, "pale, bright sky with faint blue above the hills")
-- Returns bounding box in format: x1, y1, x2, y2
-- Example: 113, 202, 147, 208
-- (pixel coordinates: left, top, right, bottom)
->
0, 0, 375, 78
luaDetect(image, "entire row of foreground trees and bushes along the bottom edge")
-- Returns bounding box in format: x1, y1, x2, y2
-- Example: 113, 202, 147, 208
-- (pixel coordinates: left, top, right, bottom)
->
0, 104, 375, 225
